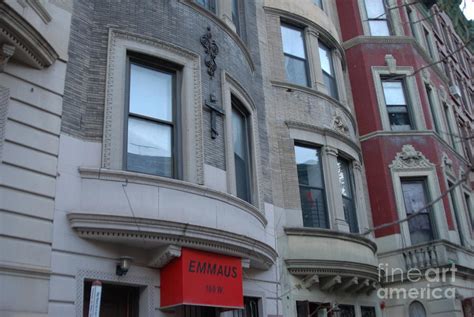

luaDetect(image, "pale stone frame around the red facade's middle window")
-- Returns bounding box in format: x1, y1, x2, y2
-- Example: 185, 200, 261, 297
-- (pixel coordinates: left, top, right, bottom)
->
372, 66, 426, 132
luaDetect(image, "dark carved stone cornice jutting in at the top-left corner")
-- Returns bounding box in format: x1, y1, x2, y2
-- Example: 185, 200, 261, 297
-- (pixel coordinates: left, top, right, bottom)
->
0, 1, 59, 69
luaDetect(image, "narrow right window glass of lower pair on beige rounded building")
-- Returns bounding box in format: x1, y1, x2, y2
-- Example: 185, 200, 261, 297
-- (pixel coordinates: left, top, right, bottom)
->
337, 158, 359, 233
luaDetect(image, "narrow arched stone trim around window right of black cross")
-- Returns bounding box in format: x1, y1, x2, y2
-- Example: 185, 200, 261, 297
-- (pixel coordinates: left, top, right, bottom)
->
221, 71, 264, 210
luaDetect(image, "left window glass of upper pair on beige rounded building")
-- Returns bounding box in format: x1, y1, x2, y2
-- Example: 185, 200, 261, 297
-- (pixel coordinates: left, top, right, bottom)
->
281, 24, 309, 86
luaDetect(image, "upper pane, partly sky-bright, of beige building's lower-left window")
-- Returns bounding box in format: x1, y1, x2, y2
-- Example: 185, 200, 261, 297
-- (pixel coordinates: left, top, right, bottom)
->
295, 146, 324, 188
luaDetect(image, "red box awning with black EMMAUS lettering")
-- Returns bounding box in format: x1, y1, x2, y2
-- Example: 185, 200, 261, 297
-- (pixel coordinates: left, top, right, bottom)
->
160, 248, 244, 308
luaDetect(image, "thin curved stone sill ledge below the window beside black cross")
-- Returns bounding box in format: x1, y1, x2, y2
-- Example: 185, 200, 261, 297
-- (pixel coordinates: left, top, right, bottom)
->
79, 167, 268, 226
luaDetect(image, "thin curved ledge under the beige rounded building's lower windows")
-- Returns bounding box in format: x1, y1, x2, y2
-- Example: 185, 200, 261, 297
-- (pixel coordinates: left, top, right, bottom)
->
284, 227, 377, 254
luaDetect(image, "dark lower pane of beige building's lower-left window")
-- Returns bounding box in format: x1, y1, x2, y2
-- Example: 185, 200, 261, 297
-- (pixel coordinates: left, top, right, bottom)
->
300, 186, 329, 228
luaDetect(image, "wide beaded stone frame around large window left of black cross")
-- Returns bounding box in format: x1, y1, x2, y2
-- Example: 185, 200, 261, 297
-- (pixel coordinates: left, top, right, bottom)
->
101, 29, 204, 184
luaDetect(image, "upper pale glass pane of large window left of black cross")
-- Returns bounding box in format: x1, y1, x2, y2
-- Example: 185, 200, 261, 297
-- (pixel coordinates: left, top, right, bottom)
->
130, 64, 173, 122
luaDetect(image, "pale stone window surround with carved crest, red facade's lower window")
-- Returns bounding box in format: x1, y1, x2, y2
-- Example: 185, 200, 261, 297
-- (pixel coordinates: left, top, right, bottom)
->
389, 144, 449, 248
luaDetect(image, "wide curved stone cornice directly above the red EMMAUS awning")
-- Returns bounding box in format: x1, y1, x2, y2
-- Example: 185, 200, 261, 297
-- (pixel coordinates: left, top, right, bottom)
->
68, 212, 277, 269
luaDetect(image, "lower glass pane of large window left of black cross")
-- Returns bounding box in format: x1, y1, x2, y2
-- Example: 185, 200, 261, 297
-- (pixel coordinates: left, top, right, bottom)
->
127, 118, 173, 177
